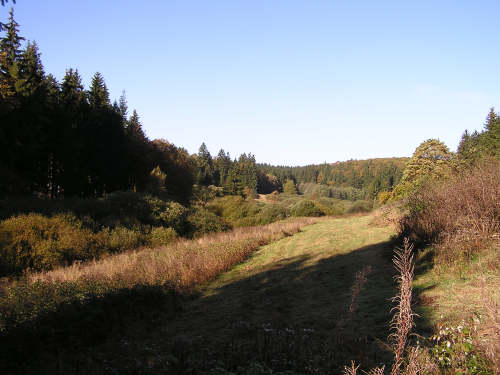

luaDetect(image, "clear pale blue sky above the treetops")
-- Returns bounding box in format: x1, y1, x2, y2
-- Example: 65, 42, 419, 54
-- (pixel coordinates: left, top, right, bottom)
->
0, 0, 500, 165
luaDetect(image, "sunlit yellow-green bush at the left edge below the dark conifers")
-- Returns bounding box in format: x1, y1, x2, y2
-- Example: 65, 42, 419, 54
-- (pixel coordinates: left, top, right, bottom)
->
0, 214, 108, 275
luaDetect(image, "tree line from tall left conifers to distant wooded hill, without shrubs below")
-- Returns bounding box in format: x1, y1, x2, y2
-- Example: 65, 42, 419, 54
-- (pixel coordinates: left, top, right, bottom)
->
0, 10, 404, 203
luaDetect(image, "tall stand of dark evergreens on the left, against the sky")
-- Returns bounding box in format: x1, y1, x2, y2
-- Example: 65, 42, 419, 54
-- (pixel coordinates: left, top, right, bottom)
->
0, 11, 194, 202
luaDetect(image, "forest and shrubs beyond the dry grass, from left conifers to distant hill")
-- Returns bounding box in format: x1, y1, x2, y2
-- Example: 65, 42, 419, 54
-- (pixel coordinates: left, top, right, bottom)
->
0, 10, 406, 274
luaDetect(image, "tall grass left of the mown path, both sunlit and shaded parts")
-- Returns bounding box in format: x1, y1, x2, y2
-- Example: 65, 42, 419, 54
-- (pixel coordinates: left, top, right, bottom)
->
0, 218, 318, 373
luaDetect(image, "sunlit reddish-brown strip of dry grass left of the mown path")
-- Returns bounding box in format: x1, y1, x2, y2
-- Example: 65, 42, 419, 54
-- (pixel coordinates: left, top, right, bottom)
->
28, 218, 317, 290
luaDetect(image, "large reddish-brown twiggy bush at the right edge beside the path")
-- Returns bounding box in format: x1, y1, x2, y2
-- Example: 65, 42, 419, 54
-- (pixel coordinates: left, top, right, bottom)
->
401, 161, 500, 262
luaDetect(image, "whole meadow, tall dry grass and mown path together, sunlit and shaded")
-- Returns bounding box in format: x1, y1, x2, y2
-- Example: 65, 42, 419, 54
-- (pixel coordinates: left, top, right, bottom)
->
2, 215, 404, 374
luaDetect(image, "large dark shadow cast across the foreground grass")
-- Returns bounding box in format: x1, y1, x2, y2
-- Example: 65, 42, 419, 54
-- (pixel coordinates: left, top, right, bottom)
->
0, 241, 426, 374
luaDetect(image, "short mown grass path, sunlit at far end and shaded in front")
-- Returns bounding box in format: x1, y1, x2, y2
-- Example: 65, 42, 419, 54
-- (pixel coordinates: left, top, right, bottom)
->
68, 215, 394, 374
